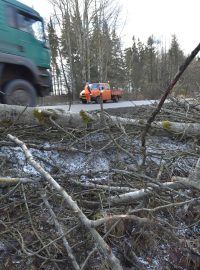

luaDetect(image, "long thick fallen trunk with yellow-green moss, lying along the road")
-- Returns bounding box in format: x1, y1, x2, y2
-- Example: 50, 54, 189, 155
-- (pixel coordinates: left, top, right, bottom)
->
0, 105, 200, 137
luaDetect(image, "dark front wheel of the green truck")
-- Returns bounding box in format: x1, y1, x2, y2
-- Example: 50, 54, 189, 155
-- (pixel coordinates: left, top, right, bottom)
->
3, 80, 37, 107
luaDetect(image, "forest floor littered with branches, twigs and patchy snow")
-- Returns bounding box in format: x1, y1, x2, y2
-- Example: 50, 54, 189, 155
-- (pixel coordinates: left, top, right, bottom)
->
0, 98, 200, 270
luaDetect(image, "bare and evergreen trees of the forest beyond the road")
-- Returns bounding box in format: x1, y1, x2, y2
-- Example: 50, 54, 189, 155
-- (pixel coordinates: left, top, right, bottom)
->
47, 0, 200, 100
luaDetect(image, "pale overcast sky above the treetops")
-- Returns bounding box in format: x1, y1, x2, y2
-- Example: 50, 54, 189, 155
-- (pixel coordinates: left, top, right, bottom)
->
21, 0, 200, 53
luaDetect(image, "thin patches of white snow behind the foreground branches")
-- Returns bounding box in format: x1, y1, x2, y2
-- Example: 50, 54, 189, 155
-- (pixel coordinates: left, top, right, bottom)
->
0, 134, 197, 181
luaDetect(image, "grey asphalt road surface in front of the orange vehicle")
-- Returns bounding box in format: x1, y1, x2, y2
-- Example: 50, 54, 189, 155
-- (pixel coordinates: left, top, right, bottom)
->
42, 100, 156, 112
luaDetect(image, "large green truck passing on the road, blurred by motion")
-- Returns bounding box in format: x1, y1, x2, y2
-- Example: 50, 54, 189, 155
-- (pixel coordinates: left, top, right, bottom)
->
0, 0, 52, 106
